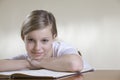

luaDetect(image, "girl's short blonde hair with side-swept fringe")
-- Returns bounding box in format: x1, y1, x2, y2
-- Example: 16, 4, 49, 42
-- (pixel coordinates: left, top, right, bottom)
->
21, 10, 57, 40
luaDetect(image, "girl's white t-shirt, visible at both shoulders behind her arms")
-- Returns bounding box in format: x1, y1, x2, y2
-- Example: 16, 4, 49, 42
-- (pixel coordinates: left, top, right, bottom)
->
12, 41, 79, 60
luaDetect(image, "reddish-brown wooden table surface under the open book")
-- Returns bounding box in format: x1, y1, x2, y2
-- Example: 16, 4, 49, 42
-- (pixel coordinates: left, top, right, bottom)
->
0, 70, 120, 80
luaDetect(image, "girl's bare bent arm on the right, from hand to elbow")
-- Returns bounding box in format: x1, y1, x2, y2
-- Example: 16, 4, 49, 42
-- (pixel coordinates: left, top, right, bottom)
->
30, 54, 83, 71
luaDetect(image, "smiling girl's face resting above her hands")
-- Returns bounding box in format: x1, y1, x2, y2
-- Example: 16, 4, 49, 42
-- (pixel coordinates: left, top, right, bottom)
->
24, 26, 54, 59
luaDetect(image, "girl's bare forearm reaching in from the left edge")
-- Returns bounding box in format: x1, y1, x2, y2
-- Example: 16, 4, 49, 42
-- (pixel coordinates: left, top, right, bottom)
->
0, 60, 29, 71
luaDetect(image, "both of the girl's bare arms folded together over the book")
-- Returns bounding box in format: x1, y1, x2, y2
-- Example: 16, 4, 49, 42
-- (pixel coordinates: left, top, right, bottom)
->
0, 54, 83, 71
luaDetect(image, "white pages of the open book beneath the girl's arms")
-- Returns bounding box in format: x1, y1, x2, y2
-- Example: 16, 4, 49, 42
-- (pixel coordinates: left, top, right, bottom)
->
0, 69, 76, 77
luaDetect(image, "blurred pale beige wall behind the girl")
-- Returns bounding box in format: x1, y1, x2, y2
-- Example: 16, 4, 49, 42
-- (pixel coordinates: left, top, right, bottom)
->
0, 0, 120, 69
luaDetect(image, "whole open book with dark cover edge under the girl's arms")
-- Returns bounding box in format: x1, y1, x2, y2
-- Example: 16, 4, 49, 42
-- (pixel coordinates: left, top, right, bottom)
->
0, 60, 93, 79
